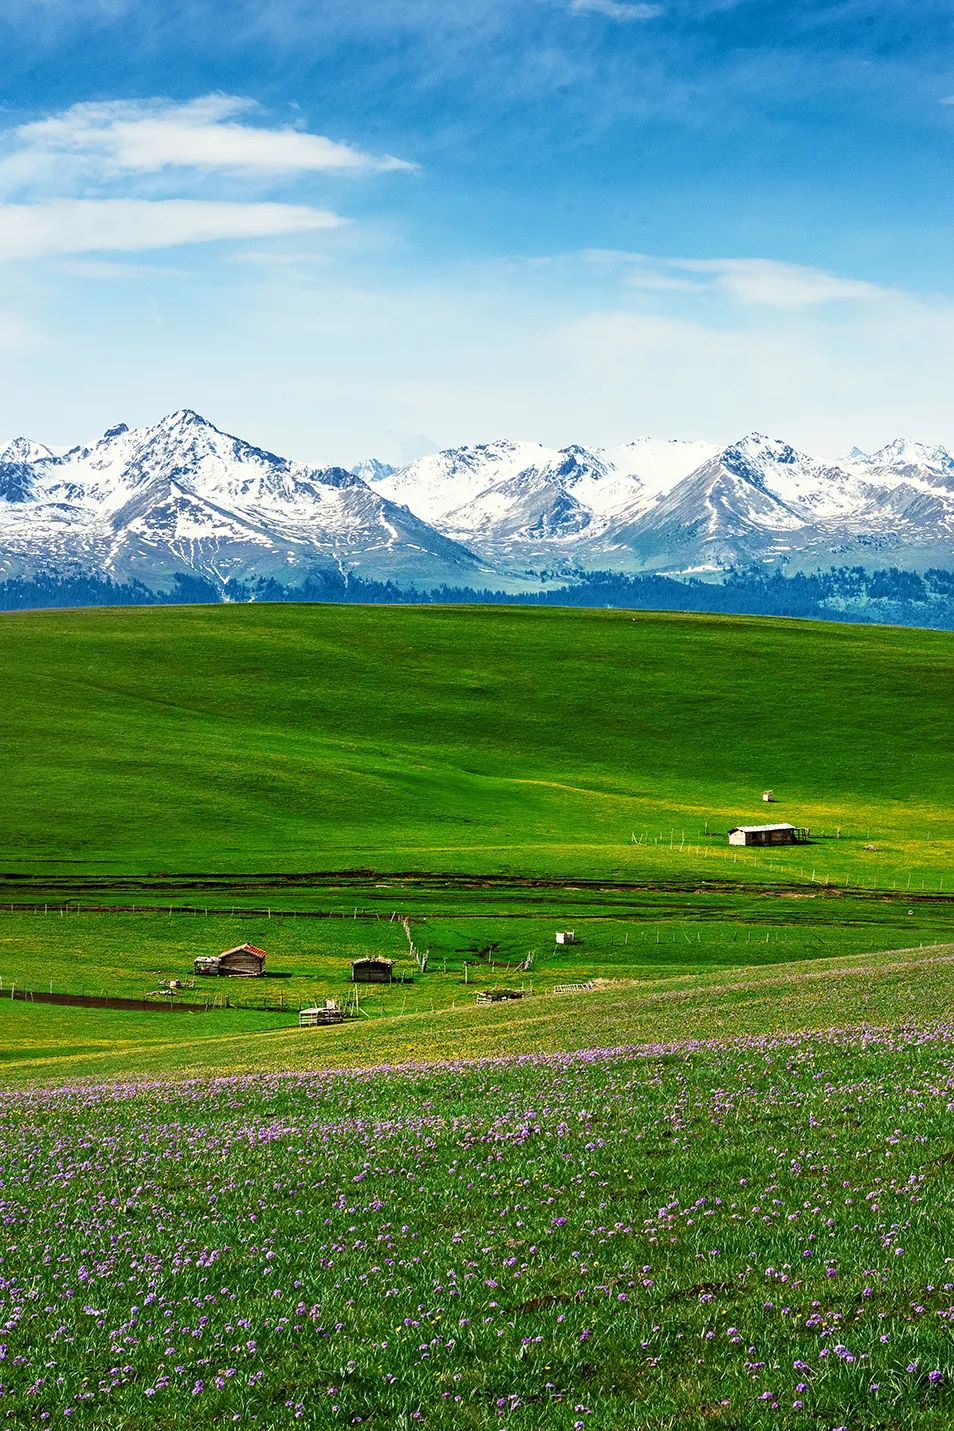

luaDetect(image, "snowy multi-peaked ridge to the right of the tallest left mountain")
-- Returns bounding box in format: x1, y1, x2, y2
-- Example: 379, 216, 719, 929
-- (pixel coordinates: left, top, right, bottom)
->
375, 434, 954, 571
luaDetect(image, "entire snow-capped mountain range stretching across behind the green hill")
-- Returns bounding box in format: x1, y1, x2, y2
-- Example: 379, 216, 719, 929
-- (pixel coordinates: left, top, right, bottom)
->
0, 409, 954, 590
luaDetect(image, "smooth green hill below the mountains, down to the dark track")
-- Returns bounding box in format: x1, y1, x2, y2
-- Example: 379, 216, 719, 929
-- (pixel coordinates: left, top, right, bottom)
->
0, 605, 954, 889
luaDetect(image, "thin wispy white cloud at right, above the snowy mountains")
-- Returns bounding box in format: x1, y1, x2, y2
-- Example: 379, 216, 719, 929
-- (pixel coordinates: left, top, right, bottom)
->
585, 249, 892, 308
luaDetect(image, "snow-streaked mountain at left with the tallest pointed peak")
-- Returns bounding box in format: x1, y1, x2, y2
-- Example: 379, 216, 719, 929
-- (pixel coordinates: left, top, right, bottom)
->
0, 409, 492, 590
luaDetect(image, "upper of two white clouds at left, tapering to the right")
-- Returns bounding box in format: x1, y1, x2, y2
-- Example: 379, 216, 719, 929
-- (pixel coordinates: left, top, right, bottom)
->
0, 94, 415, 190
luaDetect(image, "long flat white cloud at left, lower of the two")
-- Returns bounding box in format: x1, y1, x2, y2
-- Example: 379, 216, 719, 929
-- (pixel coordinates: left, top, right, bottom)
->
0, 199, 343, 259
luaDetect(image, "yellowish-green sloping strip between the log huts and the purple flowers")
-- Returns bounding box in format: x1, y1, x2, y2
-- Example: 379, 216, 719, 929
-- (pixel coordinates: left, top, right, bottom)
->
0, 944, 954, 1086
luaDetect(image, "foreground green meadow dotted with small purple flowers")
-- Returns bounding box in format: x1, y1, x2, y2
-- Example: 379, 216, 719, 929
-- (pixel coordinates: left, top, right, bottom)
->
0, 1027, 954, 1431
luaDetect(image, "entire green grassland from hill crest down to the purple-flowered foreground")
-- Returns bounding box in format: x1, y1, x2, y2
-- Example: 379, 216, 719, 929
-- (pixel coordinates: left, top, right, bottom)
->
0, 607, 954, 1431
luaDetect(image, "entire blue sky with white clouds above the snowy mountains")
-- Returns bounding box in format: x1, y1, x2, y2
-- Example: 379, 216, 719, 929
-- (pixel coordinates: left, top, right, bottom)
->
0, 0, 954, 462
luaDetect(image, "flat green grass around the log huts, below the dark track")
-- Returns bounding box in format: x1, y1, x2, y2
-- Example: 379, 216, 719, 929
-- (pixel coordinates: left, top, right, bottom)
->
0, 890, 954, 1015
